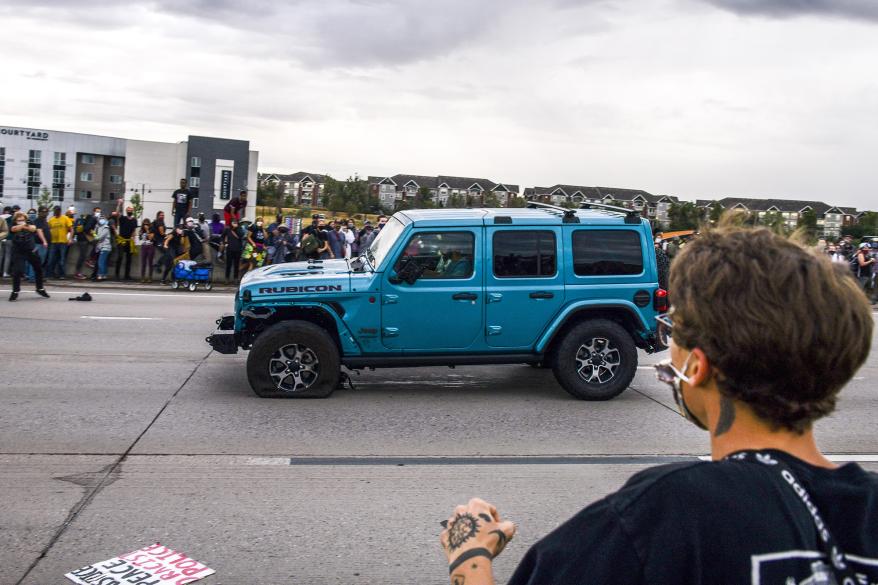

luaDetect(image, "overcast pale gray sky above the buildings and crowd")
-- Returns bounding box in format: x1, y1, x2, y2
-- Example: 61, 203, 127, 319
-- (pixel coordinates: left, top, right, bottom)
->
0, 0, 878, 209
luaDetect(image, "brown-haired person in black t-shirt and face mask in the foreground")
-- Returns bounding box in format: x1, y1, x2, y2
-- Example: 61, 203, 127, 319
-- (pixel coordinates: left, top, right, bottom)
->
440, 217, 878, 585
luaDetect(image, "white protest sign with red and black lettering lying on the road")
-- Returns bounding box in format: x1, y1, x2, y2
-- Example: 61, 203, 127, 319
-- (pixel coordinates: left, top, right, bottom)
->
64, 542, 216, 585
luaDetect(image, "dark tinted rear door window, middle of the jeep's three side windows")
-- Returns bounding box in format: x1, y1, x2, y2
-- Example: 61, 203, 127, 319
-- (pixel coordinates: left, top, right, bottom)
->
494, 230, 557, 278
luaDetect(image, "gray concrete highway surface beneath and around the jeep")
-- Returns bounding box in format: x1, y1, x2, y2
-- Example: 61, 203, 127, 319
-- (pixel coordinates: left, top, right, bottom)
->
0, 288, 878, 585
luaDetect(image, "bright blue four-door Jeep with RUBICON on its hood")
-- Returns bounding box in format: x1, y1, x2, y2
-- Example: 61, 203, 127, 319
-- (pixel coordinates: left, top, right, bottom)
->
207, 203, 667, 400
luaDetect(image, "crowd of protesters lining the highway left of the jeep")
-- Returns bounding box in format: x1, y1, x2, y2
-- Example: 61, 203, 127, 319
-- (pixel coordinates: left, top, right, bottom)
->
0, 185, 387, 300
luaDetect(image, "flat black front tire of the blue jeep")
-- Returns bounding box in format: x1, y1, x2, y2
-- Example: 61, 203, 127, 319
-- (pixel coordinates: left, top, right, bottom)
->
247, 321, 341, 398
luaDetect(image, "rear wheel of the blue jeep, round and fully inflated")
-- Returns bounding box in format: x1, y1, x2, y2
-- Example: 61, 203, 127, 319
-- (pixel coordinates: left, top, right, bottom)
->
552, 319, 637, 400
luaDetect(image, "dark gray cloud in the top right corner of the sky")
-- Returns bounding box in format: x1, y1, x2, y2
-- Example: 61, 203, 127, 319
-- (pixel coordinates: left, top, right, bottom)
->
705, 0, 878, 22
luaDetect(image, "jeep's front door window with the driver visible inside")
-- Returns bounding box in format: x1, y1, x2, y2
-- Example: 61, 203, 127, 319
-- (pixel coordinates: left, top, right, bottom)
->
394, 232, 475, 279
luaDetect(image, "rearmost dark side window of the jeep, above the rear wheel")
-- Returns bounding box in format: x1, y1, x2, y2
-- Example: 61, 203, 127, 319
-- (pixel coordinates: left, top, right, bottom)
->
573, 230, 643, 276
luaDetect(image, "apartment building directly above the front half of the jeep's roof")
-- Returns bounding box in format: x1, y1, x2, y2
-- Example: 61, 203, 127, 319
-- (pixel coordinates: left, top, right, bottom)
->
368, 174, 519, 210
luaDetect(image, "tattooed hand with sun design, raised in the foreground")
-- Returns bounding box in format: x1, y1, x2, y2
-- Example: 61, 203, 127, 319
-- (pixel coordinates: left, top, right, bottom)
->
439, 498, 515, 574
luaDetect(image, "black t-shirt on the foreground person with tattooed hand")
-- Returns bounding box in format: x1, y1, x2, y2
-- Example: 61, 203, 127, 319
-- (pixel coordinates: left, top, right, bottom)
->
509, 450, 878, 585
